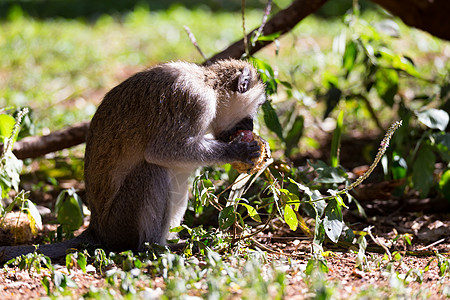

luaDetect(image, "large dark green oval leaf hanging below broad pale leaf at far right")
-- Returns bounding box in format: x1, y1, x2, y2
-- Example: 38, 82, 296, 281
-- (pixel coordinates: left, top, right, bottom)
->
412, 144, 436, 197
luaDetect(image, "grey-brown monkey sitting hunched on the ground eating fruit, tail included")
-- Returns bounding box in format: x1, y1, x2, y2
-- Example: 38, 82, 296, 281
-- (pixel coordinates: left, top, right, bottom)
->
0, 59, 266, 261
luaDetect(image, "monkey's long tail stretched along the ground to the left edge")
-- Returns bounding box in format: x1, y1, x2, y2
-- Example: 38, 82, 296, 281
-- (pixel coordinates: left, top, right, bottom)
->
0, 228, 99, 265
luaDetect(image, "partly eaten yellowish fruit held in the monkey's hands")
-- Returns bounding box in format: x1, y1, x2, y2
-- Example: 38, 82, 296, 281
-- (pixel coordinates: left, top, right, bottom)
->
231, 130, 270, 174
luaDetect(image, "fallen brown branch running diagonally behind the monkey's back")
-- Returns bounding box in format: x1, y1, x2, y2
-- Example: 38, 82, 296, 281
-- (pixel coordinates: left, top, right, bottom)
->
0, 0, 328, 159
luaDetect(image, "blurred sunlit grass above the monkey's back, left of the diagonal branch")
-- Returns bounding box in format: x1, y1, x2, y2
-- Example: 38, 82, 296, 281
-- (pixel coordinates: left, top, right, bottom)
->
0, 7, 261, 130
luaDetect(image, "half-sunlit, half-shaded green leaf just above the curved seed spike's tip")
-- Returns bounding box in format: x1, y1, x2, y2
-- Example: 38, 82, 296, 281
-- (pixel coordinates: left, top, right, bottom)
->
375, 68, 398, 107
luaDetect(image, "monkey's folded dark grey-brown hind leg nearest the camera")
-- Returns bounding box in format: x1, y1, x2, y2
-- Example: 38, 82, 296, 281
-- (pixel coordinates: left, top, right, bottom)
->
96, 161, 169, 251
